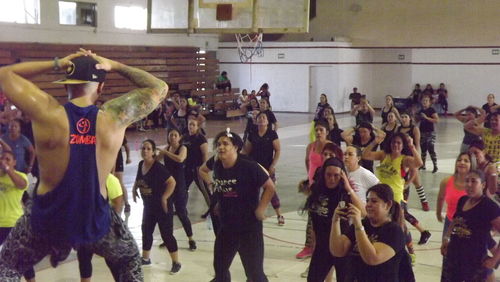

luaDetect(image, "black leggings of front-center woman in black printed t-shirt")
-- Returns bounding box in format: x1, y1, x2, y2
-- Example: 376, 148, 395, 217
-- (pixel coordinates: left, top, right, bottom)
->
214, 225, 268, 282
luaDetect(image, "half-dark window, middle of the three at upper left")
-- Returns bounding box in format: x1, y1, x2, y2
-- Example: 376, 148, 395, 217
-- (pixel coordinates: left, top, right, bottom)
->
59, 1, 97, 26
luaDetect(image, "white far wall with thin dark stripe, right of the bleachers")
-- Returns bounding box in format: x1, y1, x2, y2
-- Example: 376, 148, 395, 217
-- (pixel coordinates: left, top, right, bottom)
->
217, 42, 500, 112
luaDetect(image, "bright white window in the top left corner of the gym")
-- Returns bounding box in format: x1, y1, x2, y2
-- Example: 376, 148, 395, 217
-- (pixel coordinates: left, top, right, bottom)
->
0, 0, 40, 24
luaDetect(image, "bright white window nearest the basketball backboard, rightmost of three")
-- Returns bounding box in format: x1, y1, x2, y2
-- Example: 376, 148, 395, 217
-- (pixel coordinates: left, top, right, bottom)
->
115, 6, 148, 30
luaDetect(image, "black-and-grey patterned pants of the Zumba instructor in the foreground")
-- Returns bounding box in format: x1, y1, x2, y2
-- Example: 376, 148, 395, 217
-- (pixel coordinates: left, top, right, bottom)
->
0, 203, 144, 282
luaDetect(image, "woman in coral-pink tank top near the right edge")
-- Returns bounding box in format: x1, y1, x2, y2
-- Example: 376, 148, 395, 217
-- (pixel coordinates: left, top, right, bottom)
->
436, 152, 471, 236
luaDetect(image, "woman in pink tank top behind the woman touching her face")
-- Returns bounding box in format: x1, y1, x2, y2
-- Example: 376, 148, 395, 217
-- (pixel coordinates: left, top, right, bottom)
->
306, 120, 332, 183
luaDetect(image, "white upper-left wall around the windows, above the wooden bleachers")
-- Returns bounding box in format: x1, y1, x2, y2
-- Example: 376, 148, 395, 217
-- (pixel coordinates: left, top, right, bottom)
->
0, 0, 218, 50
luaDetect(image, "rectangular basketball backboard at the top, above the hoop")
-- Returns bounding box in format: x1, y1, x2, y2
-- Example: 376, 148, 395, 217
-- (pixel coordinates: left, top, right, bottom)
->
148, 0, 309, 33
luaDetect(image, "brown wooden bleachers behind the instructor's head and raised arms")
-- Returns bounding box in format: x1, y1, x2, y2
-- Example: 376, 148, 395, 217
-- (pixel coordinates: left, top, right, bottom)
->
0, 42, 219, 102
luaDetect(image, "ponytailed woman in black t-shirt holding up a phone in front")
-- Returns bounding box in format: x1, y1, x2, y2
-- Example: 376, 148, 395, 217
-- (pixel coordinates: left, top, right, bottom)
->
330, 184, 408, 282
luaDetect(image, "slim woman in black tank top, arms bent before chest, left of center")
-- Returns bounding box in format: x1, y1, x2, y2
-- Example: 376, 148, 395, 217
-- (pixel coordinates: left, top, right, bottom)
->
158, 128, 196, 251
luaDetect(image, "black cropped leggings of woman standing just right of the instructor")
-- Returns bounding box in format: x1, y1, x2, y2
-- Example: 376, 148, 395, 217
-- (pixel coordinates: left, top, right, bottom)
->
141, 205, 177, 253
